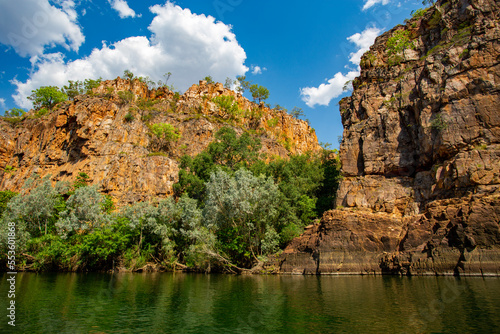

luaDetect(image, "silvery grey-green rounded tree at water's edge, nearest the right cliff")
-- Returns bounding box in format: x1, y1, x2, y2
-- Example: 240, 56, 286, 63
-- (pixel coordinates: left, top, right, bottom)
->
203, 168, 279, 267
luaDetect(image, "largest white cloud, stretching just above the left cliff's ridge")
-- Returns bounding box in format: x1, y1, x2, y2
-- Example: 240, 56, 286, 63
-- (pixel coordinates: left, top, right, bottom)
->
12, 3, 248, 108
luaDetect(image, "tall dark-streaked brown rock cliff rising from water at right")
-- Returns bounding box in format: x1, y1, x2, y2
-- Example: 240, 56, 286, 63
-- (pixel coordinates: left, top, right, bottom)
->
281, 0, 500, 275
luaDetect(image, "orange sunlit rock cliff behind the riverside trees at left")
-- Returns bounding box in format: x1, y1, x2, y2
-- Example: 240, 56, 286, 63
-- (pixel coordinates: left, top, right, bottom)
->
0, 78, 320, 205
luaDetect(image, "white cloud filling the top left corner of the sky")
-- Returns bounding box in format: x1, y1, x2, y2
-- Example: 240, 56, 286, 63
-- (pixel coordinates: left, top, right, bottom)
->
0, 0, 85, 57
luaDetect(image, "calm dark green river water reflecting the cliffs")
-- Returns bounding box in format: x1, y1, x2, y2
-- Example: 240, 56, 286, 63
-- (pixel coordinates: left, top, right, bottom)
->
0, 273, 500, 333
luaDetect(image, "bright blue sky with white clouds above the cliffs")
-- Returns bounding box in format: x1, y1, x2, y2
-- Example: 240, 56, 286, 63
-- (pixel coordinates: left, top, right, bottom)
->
0, 0, 422, 147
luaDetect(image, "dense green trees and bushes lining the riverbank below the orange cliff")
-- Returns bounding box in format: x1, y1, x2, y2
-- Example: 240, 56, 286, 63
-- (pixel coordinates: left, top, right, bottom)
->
0, 126, 339, 272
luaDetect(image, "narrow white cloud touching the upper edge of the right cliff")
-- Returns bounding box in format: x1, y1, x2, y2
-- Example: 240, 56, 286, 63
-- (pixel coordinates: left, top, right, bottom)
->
300, 27, 382, 108
